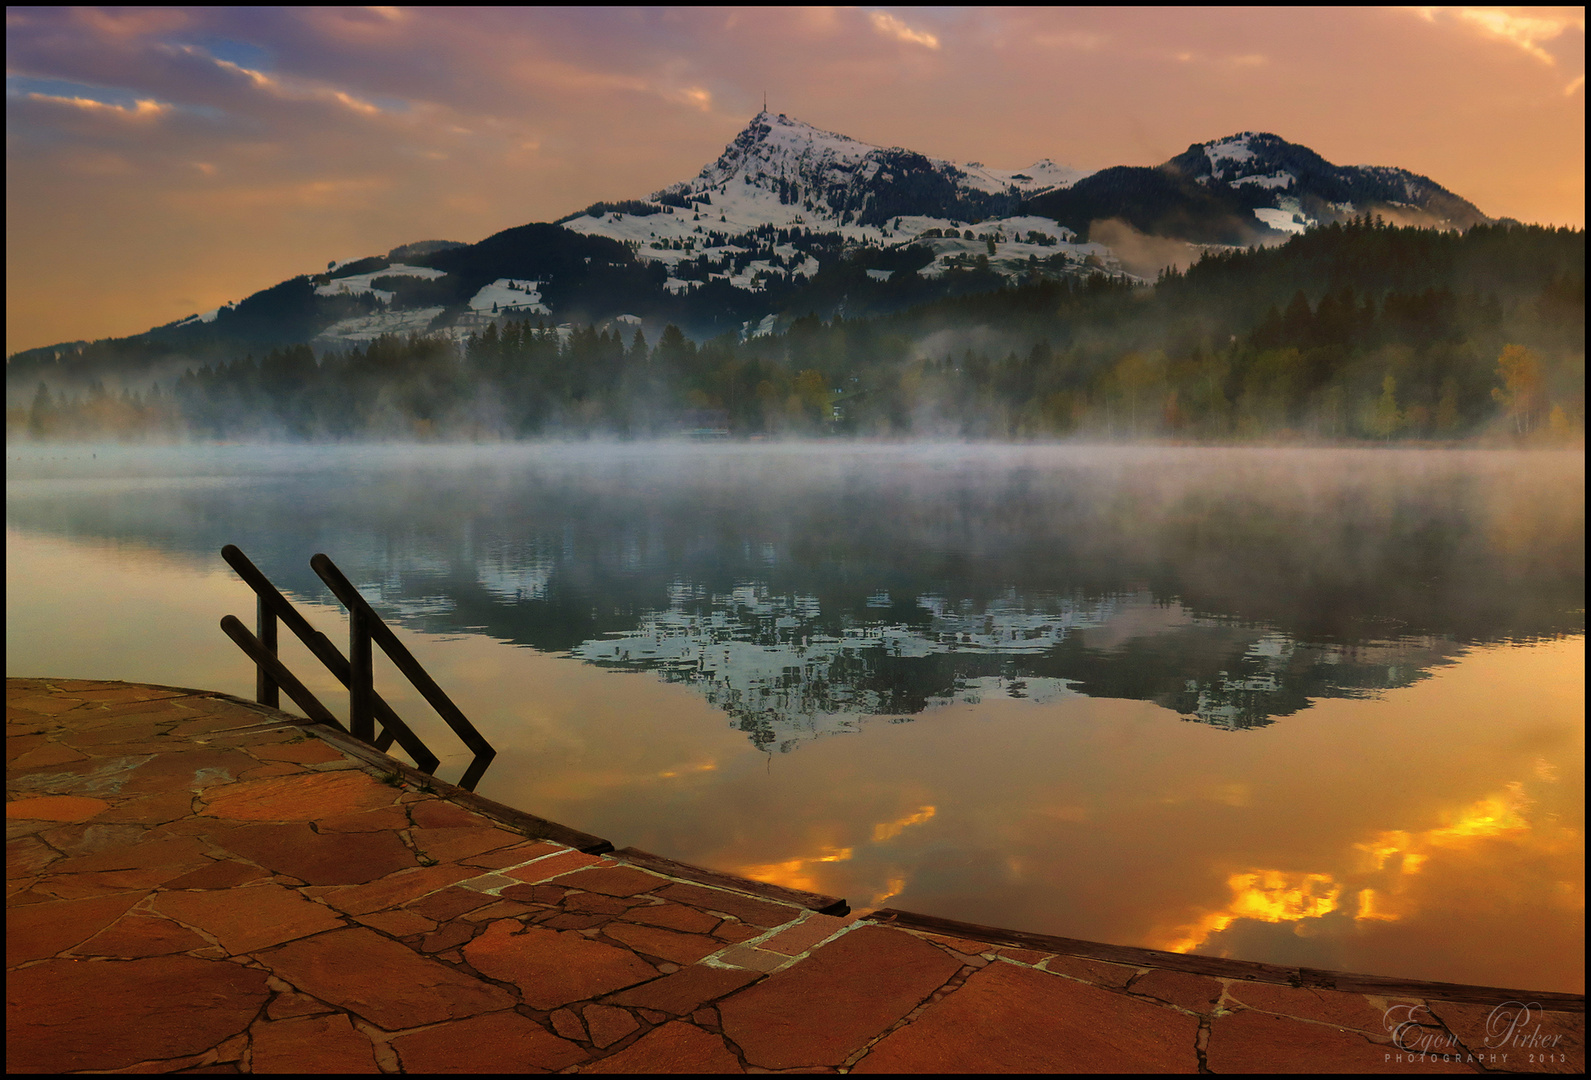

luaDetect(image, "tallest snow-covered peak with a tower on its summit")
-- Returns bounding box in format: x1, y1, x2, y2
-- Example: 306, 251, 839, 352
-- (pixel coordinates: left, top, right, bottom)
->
560, 113, 1120, 303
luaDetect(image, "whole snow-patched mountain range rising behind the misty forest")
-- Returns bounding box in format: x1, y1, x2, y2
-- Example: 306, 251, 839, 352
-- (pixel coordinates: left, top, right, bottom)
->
3, 111, 1489, 369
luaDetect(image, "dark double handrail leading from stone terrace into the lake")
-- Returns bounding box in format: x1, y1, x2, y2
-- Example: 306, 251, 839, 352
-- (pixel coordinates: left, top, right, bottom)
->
221, 544, 496, 791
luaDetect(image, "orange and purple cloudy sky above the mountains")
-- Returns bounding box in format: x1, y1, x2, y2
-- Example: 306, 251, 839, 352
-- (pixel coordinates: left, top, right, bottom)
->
6, 8, 1585, 355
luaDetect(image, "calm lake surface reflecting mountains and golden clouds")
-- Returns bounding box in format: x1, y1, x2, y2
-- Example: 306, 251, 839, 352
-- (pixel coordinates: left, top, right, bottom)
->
6, 445, 1585, 991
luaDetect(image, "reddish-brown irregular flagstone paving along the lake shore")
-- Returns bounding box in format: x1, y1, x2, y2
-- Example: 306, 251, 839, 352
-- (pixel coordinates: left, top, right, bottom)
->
6, 679, 1585, 1072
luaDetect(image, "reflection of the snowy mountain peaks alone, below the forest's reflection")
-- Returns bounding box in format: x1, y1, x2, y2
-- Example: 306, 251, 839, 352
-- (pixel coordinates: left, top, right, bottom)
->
571, 582, 1457, 751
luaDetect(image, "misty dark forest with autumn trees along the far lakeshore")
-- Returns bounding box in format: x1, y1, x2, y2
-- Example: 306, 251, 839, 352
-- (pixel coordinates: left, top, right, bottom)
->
8, 219, 1585, 441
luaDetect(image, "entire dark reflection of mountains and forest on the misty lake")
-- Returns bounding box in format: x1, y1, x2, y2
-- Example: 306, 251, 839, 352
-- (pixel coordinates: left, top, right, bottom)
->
6, 447, 1585, 751
